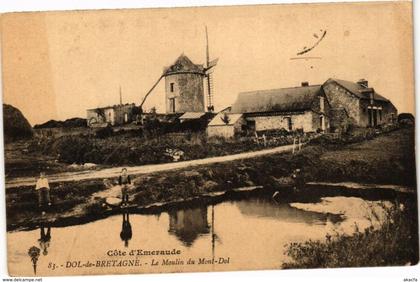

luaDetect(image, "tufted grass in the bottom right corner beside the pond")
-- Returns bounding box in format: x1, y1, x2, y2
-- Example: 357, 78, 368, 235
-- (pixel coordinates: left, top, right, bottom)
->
282, 197, 419, 268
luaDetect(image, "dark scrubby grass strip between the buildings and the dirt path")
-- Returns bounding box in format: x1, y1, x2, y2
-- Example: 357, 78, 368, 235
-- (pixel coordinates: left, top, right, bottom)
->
5, 129, 309, 177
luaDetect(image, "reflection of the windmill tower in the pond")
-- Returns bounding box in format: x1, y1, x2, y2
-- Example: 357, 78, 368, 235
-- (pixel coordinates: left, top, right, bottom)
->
168, 207, 210, 247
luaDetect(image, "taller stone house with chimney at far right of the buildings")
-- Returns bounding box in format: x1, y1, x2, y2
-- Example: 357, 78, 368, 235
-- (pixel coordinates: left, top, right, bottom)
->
322, 78, 397, 127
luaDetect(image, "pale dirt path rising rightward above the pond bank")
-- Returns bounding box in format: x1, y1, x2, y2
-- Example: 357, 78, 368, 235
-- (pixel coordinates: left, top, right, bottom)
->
6, 145, 293, 188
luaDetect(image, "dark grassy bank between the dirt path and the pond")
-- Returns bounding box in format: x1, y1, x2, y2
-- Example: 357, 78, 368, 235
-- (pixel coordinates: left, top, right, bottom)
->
6, 129, 415, 231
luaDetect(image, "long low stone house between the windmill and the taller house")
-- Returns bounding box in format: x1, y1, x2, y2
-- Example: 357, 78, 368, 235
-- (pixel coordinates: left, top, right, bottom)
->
231, 82, 330, 132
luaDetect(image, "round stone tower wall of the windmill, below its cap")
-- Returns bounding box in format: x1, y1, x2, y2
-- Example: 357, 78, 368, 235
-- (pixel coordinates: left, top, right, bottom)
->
165, 73, 205, 113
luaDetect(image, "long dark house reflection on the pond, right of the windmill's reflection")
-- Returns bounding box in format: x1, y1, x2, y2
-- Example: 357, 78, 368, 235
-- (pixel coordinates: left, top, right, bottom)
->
236, 198, 342, 224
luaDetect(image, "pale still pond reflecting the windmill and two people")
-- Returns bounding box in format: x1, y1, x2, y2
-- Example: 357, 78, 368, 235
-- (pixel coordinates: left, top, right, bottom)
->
8, 195, 389, 276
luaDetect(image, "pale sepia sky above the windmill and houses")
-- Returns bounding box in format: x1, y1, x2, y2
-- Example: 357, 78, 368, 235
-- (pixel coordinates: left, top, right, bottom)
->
1, 2, 415, 125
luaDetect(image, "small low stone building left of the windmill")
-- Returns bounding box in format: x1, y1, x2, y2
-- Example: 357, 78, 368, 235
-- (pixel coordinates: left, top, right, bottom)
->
87, 103, 138, 127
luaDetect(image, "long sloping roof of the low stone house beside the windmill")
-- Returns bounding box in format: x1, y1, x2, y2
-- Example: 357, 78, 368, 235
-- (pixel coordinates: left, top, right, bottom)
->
232, 85, 321, 113
